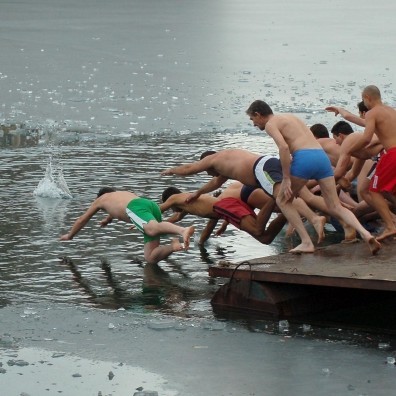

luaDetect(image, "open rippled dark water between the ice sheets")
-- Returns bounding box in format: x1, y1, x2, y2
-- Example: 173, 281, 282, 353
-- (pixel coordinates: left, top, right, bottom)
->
0, 133, 285, 315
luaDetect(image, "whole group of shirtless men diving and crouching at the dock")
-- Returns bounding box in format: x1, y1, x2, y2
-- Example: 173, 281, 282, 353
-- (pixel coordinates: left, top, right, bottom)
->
61, 85, 396, 263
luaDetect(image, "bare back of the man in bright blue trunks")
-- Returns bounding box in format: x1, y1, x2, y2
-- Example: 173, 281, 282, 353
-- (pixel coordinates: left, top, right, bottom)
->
266, 114, 321, 154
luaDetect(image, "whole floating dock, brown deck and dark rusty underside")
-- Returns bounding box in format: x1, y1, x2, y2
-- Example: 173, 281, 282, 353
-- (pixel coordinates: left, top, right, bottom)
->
209, 240, 396, 317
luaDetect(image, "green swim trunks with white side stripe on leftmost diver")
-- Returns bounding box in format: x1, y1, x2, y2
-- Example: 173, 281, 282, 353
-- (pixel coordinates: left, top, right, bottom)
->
126, 198, 162, 243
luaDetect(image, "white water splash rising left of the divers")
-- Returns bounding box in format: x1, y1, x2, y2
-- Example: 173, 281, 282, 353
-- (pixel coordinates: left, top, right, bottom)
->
33, 155, 73, 199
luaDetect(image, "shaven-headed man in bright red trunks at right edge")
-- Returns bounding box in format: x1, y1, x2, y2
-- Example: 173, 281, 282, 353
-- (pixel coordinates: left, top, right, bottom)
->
344, 85, 396, 240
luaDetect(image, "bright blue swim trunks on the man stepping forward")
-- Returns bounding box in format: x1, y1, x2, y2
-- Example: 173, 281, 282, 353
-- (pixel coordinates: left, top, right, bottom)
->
290, 149, 334, 180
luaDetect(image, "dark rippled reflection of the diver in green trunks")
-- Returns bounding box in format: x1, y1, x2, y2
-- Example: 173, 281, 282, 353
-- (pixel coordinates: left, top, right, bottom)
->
61, 257, 194, 315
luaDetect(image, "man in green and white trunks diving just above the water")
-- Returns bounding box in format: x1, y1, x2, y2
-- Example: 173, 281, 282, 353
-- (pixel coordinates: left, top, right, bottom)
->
60, 187, 194, 264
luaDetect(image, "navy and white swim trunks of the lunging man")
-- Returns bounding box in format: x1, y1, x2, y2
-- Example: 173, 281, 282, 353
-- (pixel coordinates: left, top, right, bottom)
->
253, 155, 283, 197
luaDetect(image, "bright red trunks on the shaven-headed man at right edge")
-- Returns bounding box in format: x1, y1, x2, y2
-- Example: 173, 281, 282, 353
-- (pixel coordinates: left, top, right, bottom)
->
370, 147, 396, 194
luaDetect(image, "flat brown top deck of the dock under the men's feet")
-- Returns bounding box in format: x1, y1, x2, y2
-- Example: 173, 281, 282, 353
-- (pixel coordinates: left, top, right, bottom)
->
209, 240, 396, 291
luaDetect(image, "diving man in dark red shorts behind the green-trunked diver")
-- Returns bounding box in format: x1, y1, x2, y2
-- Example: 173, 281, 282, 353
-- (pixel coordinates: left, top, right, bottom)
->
160, 187, 286, 245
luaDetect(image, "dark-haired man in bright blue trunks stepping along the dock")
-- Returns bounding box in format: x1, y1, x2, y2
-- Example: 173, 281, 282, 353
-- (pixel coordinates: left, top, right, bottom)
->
246, 100, 381, 254
